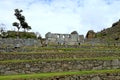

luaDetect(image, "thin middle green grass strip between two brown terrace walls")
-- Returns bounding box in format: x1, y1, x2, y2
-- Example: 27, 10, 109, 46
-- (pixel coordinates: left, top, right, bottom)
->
0, 57, 120, 63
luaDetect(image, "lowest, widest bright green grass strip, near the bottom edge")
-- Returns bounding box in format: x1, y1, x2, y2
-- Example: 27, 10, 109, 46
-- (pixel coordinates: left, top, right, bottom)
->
0, 69, 120, 80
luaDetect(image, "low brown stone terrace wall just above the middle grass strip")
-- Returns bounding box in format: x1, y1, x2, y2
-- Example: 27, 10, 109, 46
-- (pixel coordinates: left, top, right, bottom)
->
0, 50, 120, 61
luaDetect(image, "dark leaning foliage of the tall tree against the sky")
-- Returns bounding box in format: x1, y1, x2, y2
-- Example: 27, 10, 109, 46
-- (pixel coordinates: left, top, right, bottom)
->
14, 9, 31, 31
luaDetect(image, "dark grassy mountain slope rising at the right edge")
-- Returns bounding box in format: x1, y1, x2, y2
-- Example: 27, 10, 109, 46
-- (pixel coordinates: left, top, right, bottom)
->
96, 20, 120, 41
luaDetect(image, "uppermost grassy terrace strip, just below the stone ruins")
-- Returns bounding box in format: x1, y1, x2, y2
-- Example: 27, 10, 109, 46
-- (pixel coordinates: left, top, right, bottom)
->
0, 48, 120, 55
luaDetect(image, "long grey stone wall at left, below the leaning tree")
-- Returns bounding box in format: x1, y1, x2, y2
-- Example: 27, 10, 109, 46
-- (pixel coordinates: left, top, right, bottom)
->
0, 38, 41, 47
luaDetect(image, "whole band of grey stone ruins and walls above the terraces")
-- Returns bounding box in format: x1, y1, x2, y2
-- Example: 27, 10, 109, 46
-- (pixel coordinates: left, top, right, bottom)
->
0, 30, 120, 52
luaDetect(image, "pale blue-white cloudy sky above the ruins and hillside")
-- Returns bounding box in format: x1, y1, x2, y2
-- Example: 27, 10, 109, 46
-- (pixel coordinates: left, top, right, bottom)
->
0, 0, 120, 37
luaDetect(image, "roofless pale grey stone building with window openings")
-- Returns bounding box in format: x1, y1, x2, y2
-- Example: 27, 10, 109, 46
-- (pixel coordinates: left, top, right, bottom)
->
45, 32, 84, 45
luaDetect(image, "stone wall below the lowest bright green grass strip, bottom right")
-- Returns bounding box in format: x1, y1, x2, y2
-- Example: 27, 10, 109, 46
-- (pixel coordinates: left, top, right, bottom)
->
46, 73, 120, 80
